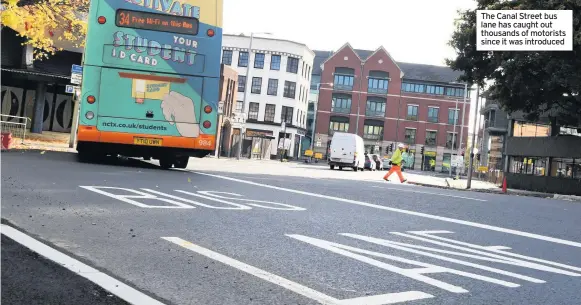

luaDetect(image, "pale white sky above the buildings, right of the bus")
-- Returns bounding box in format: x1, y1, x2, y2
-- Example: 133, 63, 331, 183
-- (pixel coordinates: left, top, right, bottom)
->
223, 0, 484, 137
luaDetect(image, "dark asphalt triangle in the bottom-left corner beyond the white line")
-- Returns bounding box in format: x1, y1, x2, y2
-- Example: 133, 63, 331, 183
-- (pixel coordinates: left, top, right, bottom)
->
1, 235, 129, 305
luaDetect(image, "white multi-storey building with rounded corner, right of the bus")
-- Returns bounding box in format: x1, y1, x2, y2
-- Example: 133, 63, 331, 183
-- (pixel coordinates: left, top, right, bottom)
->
222, 35, 315, 159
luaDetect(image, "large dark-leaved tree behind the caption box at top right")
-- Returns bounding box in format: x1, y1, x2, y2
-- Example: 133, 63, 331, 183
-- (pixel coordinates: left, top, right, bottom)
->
446, 0, 581, 126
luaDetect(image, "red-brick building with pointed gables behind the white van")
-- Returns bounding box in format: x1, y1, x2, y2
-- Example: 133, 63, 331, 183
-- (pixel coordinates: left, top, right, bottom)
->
312, 43, 470, 171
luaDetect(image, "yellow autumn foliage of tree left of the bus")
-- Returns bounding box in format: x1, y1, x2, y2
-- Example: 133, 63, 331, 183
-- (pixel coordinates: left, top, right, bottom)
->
2, 0, 90, 59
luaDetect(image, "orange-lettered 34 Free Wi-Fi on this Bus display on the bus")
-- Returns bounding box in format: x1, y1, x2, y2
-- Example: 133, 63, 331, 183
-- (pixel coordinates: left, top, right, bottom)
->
115, 9, 199, 35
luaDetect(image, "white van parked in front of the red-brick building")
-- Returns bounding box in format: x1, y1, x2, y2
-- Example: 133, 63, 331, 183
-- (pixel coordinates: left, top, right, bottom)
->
329, 132, 365, 171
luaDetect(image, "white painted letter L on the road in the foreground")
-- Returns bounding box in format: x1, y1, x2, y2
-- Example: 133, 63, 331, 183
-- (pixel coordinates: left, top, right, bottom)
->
162, 237, 434, 305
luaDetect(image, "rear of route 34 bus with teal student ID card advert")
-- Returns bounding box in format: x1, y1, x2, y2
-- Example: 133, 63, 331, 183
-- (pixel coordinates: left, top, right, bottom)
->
77, 0, 222, 168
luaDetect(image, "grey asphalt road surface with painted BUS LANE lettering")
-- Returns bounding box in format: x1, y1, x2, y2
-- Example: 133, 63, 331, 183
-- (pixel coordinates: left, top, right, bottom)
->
2, 151, 581, 305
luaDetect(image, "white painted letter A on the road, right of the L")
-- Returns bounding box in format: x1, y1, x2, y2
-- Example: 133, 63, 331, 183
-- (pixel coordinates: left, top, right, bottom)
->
287, 234, 520, 293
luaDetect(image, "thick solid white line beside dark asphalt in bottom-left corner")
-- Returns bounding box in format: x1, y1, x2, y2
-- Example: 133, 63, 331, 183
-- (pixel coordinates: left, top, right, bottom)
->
1, 224, 164, 305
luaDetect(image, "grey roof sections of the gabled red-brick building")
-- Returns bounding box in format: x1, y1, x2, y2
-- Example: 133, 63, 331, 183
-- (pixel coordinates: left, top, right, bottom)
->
313, 44, 462, 83
